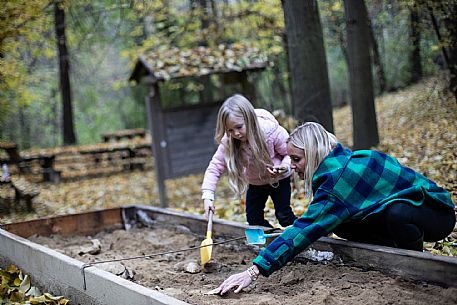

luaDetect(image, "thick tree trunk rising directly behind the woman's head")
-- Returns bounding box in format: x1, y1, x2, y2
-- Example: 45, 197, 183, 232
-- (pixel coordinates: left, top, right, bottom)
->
281, 0, 333, 132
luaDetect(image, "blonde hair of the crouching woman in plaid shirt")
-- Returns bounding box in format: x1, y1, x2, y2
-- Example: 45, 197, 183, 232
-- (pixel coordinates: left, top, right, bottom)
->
288, 122, 337, 198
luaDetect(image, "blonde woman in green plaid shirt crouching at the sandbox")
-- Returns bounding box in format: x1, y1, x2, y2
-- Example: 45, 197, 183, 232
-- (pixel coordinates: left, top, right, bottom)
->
213, 123, 456, 294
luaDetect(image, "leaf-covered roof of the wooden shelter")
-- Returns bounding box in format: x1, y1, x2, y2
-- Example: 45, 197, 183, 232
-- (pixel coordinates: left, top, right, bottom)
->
130, 43, 268, 82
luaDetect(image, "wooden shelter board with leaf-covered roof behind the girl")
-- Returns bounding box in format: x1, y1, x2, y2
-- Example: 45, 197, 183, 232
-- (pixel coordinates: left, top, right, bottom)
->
130, 44, 268, 207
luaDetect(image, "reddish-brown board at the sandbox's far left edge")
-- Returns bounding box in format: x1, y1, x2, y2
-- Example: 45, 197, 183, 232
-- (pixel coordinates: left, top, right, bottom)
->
0, 208, 122, 238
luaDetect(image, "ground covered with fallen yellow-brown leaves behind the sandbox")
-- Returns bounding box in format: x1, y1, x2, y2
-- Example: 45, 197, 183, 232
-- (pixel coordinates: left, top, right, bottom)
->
1, 76, 457, 255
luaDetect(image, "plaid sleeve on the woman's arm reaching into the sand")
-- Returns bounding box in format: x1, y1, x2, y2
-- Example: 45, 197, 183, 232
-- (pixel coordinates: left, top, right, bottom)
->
254, 192, 349, 276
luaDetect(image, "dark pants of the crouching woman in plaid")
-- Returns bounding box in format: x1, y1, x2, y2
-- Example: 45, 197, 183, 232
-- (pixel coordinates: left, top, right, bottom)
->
333, 202, 456, 251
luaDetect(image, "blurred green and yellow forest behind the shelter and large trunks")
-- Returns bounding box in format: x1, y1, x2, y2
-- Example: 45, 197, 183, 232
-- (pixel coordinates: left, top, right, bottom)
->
0, 0, 456, 150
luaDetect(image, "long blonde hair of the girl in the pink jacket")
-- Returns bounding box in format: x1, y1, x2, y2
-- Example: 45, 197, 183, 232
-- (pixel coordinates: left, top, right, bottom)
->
214, 94, 273, 196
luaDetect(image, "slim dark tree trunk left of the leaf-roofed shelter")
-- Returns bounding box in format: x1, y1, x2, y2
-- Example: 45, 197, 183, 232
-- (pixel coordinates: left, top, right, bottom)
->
54, 0, 76, 145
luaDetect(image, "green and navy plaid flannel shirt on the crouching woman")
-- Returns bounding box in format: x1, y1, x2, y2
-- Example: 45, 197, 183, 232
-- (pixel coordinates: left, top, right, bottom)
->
254, 144, 454, 276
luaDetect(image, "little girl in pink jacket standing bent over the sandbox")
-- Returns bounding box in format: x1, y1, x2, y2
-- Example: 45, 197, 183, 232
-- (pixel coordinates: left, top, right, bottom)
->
202, 94, 296, 227
